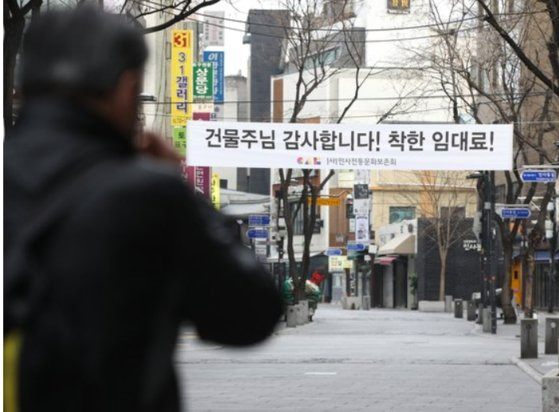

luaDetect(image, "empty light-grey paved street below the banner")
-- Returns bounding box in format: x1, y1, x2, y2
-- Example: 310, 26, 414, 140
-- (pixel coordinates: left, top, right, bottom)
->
177, 305, 541, 412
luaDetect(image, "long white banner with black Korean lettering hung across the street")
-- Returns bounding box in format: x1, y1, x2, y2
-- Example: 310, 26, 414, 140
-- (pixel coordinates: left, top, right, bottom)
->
187, 121, 513, 170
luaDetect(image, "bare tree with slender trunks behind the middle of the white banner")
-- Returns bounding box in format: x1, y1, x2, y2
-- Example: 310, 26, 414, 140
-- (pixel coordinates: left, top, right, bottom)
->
279, 0, 371, 300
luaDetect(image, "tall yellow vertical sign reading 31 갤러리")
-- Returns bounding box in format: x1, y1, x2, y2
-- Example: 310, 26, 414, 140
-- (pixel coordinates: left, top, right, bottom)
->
171, 30, 193, 126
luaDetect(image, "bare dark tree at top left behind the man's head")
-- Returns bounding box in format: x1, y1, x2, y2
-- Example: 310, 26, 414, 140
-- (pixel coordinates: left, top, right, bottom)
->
3, 0, 221, 131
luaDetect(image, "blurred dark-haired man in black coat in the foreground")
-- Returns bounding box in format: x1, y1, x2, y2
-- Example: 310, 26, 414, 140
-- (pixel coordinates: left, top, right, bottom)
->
4, 9, 281, 412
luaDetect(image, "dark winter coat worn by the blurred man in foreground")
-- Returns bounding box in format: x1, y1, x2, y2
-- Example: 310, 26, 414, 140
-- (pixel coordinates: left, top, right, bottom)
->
4, 100, 281, 412
